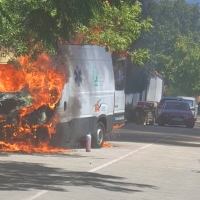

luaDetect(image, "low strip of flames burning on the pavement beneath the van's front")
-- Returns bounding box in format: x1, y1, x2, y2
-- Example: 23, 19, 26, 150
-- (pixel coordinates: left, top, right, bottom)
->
0, 141, 71, 153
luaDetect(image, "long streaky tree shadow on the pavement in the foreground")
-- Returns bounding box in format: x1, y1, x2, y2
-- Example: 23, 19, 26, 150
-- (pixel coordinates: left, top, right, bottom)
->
0, 162, 157, 193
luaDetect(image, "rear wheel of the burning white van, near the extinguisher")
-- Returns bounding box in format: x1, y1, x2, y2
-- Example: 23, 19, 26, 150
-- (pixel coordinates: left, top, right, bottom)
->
92, 122, 105, 148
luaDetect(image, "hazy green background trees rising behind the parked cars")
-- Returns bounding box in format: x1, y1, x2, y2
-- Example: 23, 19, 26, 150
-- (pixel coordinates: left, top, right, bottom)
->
143, 0, 200, 95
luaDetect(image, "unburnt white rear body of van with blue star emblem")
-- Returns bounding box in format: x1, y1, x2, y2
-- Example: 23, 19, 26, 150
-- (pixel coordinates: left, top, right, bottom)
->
54, 45, 125, 148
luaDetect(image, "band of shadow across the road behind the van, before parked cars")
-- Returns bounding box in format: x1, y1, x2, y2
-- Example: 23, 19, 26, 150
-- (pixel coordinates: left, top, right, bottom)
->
109, 124, 200, 147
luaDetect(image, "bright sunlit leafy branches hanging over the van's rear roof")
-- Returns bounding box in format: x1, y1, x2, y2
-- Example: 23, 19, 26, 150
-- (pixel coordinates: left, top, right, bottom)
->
77, 1, 152, 65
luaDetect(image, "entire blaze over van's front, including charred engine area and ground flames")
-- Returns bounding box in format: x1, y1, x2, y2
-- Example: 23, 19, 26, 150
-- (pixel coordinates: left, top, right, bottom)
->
0, 53, 67, 153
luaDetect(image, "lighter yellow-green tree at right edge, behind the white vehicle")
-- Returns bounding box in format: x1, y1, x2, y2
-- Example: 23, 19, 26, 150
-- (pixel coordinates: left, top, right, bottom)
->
169, 33, 200, 96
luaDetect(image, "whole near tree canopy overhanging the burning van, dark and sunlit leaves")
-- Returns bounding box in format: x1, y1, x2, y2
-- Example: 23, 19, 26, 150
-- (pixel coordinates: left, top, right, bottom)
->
0, 0, 151, 64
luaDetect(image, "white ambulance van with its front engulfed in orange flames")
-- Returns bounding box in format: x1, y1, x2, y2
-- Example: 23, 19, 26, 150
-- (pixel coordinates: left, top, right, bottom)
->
0, 45, 125, 148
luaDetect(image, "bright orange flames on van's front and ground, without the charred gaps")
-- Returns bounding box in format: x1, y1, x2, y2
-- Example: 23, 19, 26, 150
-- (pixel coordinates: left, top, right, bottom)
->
0, 53, 67, 153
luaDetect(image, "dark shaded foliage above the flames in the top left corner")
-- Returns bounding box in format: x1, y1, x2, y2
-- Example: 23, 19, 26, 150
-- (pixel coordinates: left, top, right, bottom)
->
0, 0, 104, 55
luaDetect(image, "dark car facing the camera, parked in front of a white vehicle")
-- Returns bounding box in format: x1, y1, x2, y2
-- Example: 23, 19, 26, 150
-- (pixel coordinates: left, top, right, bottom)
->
158, 100, 195, 128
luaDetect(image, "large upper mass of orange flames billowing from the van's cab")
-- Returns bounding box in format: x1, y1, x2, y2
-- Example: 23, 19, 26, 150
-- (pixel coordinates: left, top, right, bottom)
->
0, 54, 67, 116
